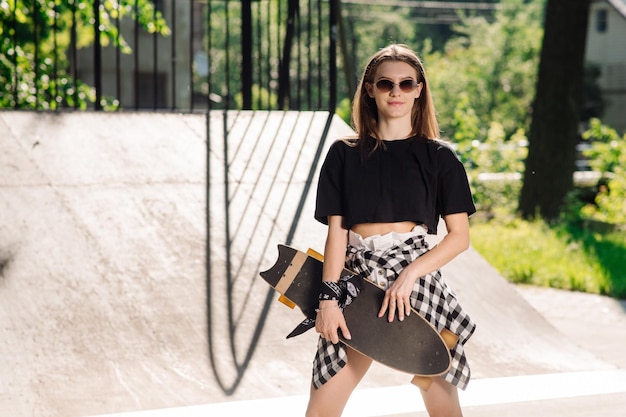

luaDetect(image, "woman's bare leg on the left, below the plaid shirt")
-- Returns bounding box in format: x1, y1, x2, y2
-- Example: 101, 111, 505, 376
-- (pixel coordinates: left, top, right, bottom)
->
306, 347, 372, 417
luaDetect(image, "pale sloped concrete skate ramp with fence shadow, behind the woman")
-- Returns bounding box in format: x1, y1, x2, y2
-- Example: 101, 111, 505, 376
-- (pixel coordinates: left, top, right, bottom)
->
0, 112, 611, 417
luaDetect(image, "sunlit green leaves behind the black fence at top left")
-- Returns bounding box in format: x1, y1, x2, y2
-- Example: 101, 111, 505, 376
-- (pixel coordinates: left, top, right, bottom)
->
0, 0, 169, 109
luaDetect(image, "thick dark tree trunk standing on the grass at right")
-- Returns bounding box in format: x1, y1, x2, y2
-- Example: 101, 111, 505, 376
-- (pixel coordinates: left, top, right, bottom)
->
519, 0, 591, 220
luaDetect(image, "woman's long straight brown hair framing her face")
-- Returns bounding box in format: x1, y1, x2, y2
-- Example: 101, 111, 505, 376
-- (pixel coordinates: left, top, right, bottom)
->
352, 44, 440, 151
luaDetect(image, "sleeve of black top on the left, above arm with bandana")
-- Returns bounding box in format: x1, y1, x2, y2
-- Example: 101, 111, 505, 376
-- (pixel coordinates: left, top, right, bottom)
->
315, 141, 346, 224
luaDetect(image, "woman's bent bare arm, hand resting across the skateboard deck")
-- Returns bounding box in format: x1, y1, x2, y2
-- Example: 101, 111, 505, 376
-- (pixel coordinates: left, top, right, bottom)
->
378, 213, 470, 321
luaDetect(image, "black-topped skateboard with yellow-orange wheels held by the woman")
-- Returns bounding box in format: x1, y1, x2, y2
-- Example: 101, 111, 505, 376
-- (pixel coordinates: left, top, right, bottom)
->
260, 245, 457, 389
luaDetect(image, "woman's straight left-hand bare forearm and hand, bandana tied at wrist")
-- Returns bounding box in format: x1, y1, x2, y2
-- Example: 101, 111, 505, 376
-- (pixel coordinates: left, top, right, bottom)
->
315, 216, 350, 343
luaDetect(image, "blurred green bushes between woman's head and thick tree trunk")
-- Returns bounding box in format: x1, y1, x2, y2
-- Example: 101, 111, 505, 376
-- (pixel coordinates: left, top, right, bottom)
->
410, 0, 544, 218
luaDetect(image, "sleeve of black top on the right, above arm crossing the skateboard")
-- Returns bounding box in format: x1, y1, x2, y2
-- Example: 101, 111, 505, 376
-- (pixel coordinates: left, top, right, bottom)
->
437, 145, 476, 216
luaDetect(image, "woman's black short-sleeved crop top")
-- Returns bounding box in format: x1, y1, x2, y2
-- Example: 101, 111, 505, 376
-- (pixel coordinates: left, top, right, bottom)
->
315, 137, 476, 234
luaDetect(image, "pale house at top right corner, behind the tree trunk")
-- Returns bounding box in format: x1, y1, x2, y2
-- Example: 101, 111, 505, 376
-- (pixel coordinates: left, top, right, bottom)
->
586, 0, 626, 133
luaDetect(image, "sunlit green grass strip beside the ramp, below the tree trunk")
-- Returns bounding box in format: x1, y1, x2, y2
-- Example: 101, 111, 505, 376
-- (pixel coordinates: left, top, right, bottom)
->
471, 219, 626, 299
